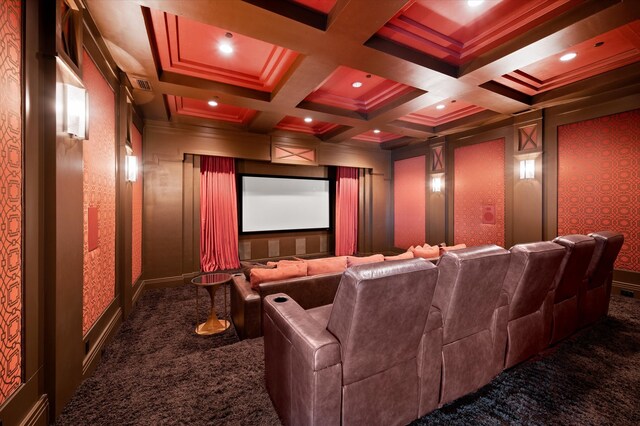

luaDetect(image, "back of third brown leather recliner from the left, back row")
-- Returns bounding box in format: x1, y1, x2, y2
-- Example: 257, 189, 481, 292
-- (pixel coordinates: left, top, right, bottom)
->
504, 241, 566, 368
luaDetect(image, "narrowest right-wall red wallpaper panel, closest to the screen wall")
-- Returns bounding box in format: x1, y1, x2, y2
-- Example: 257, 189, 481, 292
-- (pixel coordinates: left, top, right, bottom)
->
393, 155, 426, 248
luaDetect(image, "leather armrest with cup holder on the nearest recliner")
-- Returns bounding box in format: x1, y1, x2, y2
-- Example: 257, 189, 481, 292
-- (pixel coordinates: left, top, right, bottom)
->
263, 293, 341, 371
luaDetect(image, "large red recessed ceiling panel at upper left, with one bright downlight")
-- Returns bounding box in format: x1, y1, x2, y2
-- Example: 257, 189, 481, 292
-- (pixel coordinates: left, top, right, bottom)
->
150, 10, 298, 92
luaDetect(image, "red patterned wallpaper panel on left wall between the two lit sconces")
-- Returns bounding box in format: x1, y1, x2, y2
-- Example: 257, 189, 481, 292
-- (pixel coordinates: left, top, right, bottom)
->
82, 51, 116, 334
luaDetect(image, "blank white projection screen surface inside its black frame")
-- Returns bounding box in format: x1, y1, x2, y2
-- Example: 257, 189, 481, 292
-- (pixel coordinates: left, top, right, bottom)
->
242, 176, 329, 232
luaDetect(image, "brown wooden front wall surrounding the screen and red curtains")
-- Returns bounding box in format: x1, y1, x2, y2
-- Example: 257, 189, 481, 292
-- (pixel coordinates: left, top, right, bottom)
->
143, 121, 390, 286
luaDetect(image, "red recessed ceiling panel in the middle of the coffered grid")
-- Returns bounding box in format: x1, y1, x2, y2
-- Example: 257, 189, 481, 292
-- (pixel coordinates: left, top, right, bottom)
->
305, 66, 417, 114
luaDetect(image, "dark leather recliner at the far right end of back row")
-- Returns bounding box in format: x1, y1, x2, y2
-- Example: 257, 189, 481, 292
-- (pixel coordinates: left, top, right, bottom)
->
578, 231, 624, 327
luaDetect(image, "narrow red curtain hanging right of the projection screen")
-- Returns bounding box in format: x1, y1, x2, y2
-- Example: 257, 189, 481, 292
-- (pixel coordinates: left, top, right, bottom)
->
336, 167, 358, 256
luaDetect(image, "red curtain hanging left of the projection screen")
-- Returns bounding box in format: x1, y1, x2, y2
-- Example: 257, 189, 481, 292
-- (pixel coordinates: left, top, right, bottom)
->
200, 156, 240, 272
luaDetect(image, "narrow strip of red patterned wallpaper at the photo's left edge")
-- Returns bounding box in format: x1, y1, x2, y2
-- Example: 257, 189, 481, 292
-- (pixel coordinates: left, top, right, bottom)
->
0, 1, 22, 404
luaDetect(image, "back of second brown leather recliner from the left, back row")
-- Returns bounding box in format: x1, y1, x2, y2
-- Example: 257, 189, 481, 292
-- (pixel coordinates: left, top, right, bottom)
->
433, 245, 511, 404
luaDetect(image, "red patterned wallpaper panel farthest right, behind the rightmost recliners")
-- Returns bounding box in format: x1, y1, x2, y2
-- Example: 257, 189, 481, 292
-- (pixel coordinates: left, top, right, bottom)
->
558, 109, 640, 272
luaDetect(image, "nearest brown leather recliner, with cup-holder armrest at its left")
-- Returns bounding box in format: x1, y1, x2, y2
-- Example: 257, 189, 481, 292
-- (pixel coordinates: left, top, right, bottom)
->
263, 259, 438, 425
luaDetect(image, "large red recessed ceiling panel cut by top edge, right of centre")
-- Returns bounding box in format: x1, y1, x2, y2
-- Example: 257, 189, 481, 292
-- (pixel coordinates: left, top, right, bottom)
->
377, 0, 583, 65
